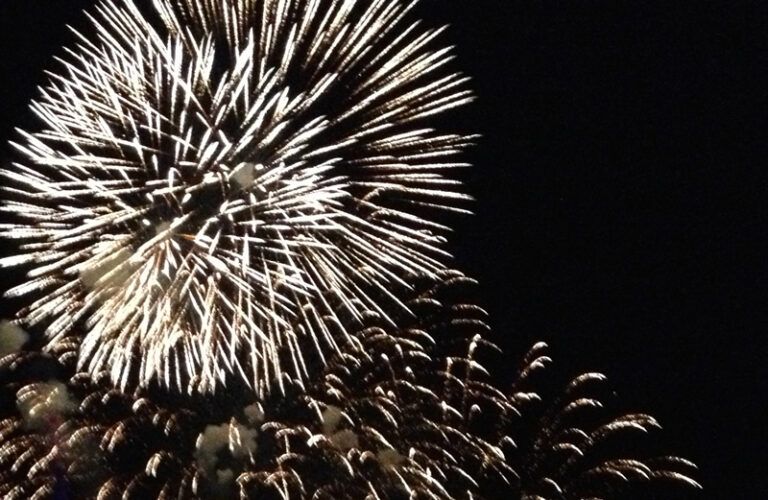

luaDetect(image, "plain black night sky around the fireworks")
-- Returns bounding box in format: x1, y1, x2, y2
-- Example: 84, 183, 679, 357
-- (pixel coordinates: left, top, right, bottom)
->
0, 0, 768, 498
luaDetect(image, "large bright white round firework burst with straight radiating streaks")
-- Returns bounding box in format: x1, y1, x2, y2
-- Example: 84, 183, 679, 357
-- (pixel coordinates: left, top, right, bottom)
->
0, 0, 474, 395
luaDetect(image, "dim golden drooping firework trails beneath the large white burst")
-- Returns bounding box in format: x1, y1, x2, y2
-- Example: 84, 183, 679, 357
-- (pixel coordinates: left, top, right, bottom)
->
0, 272, 696, 500
